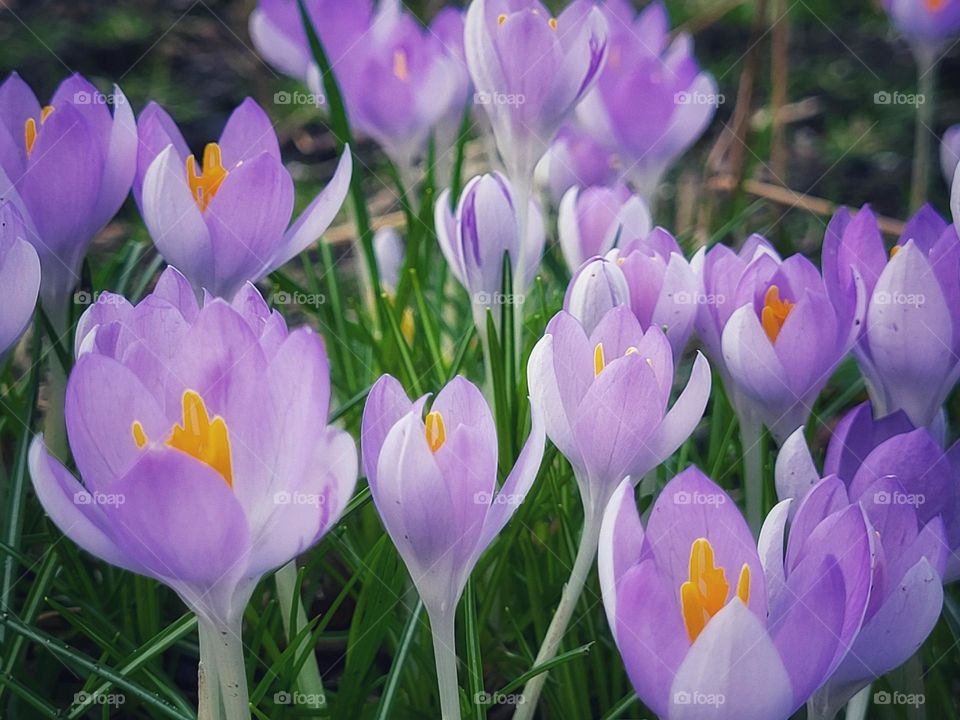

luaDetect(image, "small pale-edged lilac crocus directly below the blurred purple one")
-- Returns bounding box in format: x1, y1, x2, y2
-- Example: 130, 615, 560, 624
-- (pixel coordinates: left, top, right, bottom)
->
557, 185, 653, 272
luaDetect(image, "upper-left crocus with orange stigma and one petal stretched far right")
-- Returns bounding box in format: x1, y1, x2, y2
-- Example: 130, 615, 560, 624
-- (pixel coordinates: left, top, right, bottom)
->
135, 98, 352, 299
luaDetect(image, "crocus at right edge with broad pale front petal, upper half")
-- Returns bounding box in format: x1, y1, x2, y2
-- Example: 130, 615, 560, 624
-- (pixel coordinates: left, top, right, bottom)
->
823, 206, 960, 426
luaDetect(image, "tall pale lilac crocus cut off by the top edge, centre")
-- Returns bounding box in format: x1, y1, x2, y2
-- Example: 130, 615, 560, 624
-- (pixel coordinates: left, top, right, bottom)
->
465, 0, 607, 185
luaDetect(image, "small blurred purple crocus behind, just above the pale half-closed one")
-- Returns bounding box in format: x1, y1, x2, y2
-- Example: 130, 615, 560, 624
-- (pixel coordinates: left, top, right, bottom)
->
536, 125, 617, 204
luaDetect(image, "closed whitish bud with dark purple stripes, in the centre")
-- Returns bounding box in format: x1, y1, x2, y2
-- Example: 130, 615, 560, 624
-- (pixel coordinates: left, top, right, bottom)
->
435, 173, 544, 335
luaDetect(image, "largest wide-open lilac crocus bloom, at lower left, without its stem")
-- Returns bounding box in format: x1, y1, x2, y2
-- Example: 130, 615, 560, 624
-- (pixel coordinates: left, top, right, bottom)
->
30, 269, 357, 626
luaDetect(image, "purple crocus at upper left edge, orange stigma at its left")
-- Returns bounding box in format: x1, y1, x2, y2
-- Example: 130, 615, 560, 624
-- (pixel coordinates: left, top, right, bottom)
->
0, 73, 137, 320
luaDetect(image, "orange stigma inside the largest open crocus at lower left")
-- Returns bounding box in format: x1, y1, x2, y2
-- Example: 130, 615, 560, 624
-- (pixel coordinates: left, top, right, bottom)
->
131, 390, 233, 488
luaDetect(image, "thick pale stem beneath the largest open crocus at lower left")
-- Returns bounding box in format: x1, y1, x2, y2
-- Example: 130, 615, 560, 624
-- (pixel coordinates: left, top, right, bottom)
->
197, 617, 250, 720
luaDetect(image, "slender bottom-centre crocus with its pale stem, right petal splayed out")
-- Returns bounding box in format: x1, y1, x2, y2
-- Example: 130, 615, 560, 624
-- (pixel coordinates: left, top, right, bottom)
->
361, 375, 545, 720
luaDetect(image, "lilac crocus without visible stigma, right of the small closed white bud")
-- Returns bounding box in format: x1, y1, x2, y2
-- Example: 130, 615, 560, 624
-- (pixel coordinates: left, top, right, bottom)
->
607, 227, 701, 361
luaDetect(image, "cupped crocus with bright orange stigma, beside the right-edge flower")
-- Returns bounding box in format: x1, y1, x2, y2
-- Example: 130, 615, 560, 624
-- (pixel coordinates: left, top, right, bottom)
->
692, 235, 863, 442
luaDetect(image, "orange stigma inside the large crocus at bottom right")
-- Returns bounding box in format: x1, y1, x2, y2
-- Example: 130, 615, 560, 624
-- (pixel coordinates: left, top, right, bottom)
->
680, 538, 750, 642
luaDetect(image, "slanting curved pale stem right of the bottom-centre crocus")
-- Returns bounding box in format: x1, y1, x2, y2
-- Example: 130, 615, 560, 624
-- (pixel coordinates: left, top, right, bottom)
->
513, 502, 606, 720
